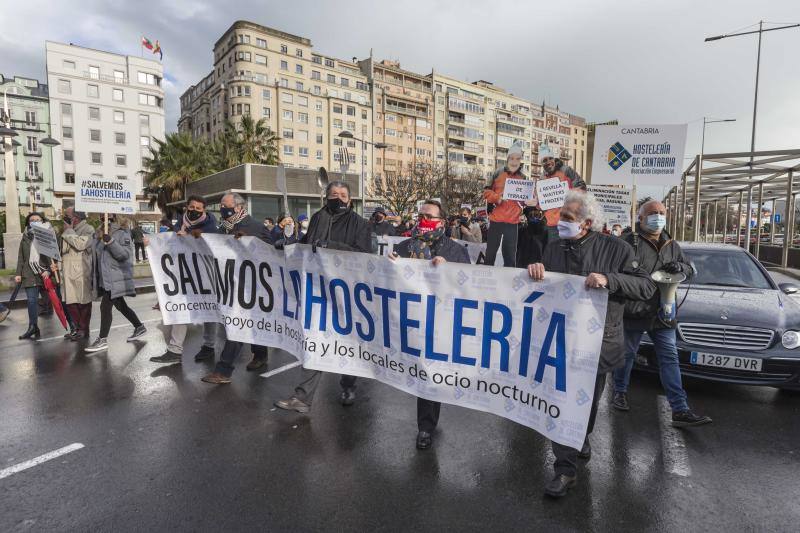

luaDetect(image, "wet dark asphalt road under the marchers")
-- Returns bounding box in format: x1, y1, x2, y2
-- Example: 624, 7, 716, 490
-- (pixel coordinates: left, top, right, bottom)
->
0, 294, 800, 532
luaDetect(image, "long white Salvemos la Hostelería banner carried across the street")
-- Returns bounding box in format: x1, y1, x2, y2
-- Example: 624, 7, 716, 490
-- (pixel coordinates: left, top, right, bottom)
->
148, 233, 607, 448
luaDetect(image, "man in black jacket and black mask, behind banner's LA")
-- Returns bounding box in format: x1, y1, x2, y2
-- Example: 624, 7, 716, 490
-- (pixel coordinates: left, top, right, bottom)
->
275, 181, 372, 413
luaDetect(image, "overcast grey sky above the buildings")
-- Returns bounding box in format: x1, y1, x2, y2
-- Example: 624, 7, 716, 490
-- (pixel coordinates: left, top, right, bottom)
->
0, 0, 800, 165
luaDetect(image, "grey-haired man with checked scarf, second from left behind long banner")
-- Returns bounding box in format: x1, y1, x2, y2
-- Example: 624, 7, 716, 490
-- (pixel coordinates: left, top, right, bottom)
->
201, 193, 272, 385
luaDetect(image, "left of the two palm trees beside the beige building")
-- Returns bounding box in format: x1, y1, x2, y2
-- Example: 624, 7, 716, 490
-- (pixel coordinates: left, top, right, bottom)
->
141, 133, 217, 212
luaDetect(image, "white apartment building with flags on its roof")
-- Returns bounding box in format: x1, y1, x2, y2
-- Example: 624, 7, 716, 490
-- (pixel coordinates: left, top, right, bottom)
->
46, 41, 164, 212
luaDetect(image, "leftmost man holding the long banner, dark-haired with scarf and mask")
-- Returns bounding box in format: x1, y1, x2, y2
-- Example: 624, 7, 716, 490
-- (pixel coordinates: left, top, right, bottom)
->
144, 195, 223, 364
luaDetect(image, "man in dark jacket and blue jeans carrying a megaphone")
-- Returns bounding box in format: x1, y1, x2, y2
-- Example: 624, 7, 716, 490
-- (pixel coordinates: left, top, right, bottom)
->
611, 200, 711, 427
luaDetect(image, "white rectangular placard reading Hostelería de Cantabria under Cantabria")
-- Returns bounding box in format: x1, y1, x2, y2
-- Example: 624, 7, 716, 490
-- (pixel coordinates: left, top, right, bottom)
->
592, 124, 686, 187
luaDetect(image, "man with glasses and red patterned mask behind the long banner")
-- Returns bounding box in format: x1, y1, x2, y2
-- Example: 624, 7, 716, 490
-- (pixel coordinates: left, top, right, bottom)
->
390, 200, 470, 450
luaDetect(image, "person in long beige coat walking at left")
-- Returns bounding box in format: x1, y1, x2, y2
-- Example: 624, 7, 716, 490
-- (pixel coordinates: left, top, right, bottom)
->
61, 207, 94, 341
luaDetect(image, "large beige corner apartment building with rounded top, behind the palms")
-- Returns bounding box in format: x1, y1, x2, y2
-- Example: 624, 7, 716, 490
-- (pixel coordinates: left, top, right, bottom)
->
178, 21, 373, 196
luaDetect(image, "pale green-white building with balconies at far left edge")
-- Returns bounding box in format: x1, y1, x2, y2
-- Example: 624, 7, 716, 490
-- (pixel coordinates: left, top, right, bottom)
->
0, 74, 53, 216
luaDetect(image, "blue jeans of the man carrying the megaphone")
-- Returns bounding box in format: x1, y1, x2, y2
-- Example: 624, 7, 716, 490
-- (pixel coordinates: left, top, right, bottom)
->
614, 329, 689, 413
